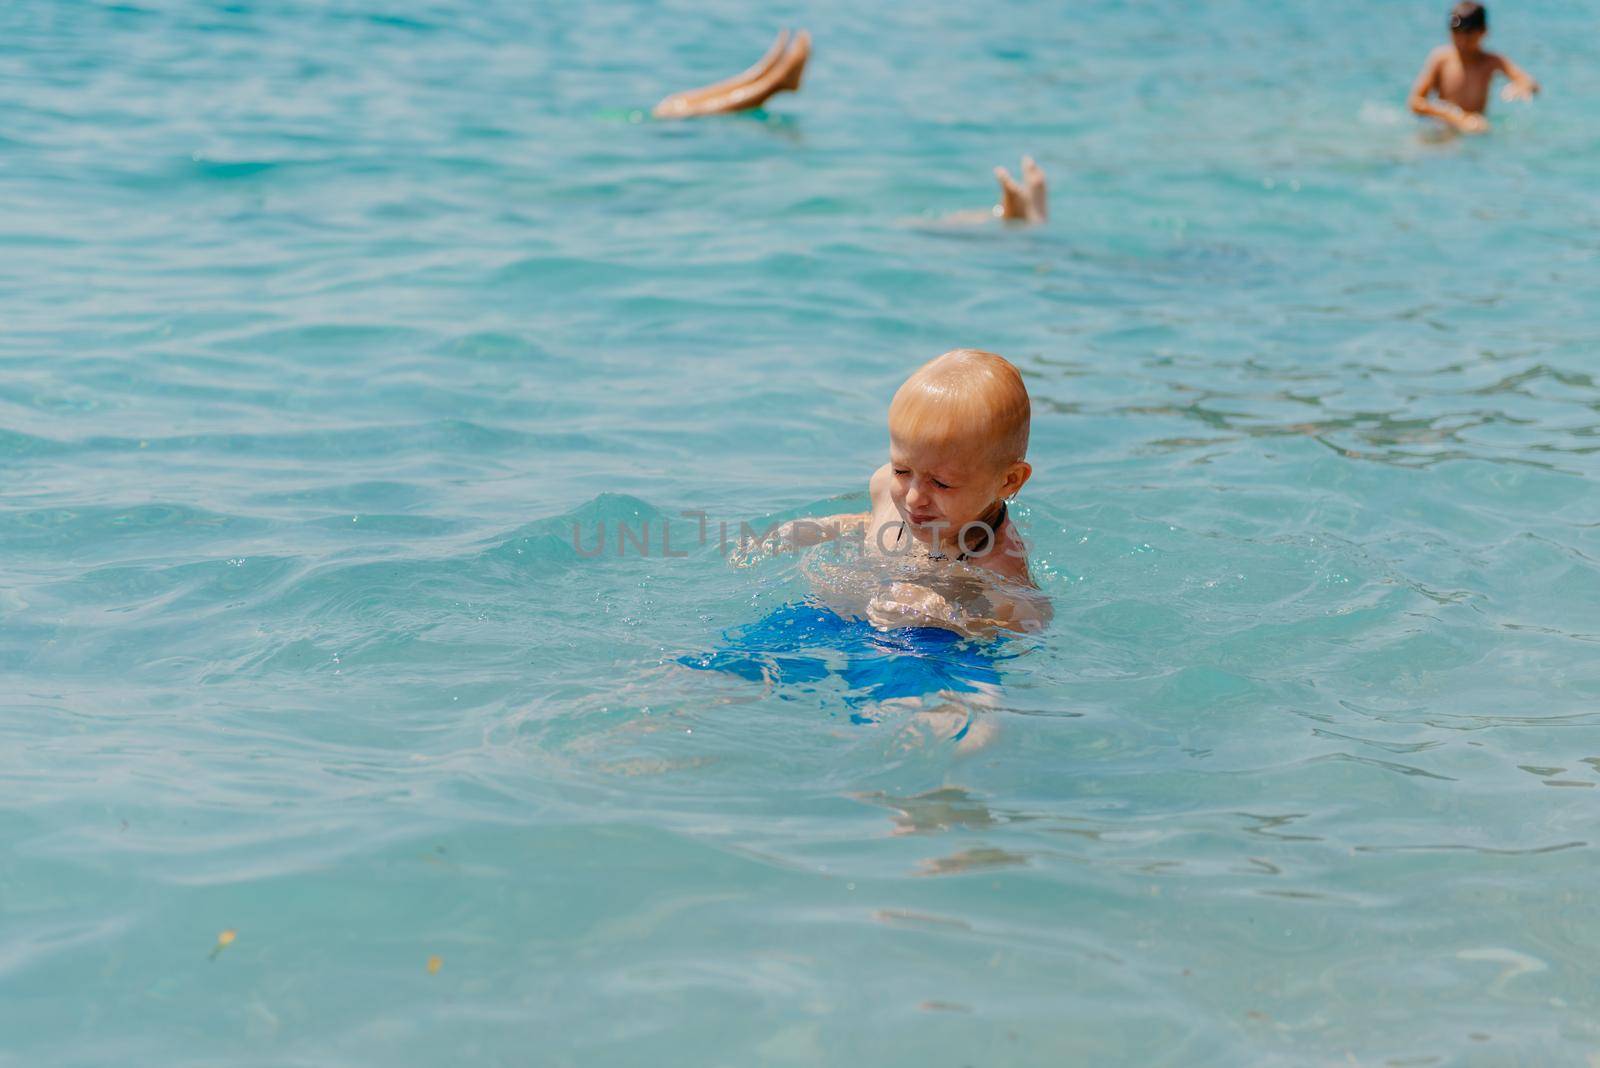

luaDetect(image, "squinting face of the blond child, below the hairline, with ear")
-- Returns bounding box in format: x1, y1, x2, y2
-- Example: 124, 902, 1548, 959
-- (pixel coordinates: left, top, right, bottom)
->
890, 428, 1030, 542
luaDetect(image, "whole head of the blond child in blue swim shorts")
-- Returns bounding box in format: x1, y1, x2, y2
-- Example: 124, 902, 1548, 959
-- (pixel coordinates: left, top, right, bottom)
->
890, 349, 1034, 540
